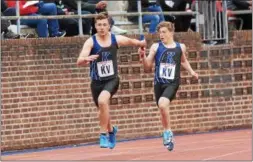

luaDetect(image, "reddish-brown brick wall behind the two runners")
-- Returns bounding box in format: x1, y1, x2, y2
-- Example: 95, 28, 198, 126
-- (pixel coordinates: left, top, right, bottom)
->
1, 32, 252, 151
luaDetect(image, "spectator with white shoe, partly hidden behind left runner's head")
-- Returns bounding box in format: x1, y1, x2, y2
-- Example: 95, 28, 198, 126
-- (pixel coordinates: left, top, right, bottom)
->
62, 0, 127, 35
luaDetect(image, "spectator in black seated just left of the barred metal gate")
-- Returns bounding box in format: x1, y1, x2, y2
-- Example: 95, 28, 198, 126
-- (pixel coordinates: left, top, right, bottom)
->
158, 0, 193, 32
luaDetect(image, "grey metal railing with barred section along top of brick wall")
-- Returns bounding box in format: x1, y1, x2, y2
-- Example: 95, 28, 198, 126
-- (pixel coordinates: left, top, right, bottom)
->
1, 0, 252, 42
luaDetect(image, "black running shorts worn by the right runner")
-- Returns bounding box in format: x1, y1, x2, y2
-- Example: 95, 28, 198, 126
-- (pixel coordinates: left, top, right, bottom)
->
154, 82, 179, 105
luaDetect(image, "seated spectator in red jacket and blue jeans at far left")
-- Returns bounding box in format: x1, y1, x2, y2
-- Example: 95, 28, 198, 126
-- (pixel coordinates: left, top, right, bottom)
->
6, 0, 66, 37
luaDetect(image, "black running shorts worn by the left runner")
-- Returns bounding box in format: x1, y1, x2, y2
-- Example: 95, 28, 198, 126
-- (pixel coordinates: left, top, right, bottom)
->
91, 77, 119, 107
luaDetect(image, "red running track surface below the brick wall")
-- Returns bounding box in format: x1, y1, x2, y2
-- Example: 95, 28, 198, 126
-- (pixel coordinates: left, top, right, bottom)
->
2, 129, 252, 161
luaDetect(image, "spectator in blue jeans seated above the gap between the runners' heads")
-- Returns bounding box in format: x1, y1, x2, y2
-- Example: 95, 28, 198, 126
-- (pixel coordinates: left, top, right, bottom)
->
127, 0, 164, 34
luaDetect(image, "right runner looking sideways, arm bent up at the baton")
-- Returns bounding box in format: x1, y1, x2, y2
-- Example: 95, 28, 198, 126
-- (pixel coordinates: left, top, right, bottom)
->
138, 22, 198, 151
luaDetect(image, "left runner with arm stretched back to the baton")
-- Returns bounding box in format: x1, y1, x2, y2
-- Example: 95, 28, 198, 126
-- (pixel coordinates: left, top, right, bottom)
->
77, 13, 146, 149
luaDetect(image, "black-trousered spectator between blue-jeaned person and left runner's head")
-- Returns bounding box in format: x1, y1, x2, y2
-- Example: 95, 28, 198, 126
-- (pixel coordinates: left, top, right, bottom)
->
44, 0, 91, 36
